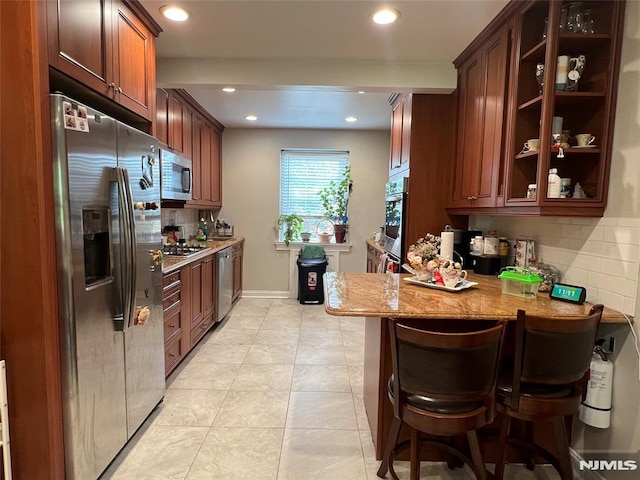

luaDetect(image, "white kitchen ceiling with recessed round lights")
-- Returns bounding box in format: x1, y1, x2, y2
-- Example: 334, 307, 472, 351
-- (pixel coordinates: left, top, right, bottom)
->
141, 0, 507, 129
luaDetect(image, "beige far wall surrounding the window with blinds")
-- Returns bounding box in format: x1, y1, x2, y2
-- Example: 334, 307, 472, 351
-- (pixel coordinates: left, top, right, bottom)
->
219, 127, 391, 294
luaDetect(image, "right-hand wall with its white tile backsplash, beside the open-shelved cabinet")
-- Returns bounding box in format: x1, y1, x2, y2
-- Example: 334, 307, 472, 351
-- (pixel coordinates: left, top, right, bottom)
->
469, 1, 640, 460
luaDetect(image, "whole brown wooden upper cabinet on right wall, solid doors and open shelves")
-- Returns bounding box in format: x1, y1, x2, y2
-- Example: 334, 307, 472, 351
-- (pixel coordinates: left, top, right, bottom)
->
449, 0, 625, 216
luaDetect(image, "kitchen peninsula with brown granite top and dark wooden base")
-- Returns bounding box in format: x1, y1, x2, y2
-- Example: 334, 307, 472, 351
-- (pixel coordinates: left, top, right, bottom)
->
324, 272, 626, 459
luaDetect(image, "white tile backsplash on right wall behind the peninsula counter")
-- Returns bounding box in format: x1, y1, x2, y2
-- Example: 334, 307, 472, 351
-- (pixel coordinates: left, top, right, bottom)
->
469, 216, 640, 315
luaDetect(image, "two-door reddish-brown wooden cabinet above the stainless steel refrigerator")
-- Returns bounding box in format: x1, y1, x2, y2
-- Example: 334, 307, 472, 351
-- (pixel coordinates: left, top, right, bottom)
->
47, 0, 161, 121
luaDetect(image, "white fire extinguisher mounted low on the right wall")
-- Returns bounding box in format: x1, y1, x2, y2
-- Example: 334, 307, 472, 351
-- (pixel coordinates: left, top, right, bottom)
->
580, 345, 613, 428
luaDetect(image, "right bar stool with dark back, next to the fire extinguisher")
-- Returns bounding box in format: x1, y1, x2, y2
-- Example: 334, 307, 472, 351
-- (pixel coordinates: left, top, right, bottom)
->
495, 305, 604, 480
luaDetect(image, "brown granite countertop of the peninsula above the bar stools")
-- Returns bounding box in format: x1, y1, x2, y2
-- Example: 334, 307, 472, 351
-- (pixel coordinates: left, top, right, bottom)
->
324, 272, 626, 323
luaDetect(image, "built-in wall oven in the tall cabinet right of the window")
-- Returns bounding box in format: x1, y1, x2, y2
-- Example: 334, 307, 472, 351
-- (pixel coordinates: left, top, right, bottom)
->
380, 177, 409, 272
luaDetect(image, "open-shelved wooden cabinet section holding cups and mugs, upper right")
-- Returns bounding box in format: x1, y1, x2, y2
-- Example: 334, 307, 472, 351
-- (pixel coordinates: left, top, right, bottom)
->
504, 1, 624, 216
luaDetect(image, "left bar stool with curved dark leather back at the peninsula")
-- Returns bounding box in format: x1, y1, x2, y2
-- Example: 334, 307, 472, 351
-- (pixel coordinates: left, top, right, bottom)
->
377, 319, 504, 480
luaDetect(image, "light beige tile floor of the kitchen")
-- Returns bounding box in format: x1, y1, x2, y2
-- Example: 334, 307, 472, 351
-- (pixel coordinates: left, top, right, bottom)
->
101, 299, 558, 480
